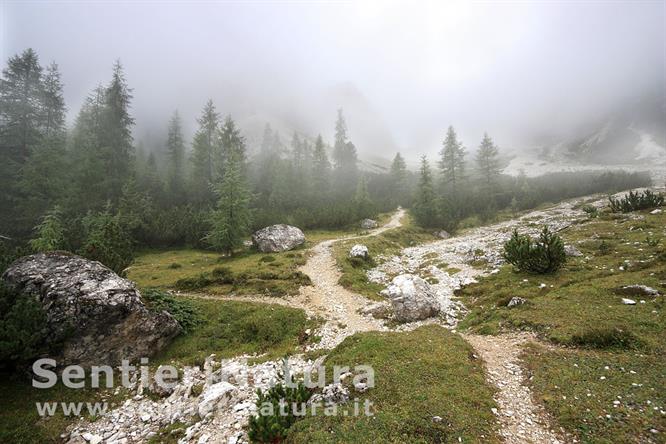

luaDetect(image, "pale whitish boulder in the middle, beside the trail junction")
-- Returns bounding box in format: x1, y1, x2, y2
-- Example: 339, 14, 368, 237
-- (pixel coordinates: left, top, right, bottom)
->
382, 274, 440, 322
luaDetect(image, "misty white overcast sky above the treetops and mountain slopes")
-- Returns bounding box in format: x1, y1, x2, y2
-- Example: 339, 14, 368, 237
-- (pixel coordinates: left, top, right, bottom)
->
0, 0, 666, 157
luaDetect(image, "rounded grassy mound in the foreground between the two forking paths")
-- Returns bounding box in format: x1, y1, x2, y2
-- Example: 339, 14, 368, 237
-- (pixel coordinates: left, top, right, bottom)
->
287, 325, 500, 443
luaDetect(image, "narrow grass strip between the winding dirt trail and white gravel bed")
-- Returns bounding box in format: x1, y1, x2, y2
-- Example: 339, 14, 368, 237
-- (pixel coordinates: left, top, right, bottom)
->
333, 214, 436, 300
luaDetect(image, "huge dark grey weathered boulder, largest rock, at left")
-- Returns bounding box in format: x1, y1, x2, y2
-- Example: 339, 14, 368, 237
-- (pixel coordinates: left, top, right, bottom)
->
2, 252, 181, 368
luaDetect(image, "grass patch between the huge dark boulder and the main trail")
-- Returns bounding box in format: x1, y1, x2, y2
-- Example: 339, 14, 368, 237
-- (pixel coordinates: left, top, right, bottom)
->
151, 297, 316, 365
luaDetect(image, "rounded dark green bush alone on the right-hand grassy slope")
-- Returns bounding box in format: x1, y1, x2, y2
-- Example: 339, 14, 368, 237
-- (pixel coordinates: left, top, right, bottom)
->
504, 227, 566, 274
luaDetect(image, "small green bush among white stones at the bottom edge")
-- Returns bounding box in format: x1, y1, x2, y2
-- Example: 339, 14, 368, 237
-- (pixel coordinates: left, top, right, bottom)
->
248, 382, 312, 443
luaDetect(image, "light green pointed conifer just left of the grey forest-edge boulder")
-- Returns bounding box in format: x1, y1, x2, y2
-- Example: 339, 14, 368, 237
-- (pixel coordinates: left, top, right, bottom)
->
206, 117, 251, 254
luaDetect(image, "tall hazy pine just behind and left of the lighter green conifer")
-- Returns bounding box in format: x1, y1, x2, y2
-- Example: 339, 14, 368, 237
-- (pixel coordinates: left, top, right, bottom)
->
191, 100, 220, 204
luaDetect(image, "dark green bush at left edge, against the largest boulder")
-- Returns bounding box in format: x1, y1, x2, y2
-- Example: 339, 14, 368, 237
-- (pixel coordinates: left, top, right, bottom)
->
0, 283, 47, 368
